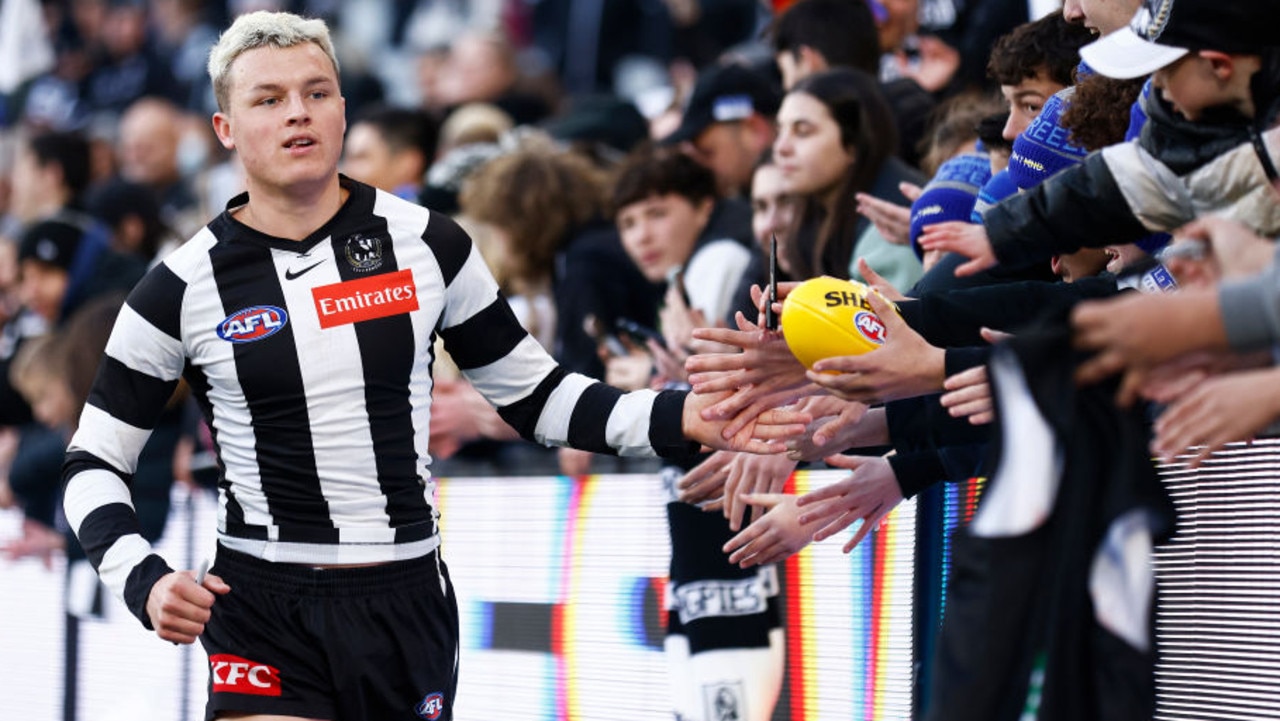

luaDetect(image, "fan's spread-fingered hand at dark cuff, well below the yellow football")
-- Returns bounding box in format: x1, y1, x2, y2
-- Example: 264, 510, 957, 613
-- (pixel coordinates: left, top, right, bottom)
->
796, 456, 902, 553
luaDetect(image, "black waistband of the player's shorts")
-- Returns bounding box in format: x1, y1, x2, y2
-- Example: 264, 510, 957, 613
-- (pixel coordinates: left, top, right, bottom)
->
210, 544, 445, 597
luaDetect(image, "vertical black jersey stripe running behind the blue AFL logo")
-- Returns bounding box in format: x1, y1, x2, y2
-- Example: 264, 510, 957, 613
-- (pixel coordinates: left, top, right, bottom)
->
209, 242, 333, 528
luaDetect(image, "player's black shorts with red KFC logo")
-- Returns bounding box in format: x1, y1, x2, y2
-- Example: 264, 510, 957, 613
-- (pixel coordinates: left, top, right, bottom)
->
200, 547, 458, 721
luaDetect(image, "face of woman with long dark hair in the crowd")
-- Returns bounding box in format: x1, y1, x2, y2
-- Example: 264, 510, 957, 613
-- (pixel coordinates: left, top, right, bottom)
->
773, 92, 854, 195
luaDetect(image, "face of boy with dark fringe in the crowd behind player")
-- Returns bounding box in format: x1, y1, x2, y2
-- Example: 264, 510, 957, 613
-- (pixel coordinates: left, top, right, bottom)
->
617, 193, 713, 283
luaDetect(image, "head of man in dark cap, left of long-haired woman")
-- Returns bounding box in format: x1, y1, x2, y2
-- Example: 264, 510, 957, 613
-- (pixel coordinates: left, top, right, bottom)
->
662, 64, 781, 197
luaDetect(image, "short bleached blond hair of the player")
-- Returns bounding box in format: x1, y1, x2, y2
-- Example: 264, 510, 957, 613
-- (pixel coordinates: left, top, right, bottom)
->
209, 10, 338, 113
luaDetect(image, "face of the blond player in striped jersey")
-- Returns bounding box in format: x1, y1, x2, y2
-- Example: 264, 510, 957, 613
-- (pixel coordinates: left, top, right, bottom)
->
214, 42, 347, 195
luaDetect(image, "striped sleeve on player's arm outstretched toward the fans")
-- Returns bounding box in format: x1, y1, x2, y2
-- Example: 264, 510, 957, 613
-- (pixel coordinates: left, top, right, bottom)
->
429, 212, 698, 457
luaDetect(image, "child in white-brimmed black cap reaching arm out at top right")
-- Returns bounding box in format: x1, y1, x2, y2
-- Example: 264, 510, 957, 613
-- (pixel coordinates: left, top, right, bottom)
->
922, 0, 1280, 274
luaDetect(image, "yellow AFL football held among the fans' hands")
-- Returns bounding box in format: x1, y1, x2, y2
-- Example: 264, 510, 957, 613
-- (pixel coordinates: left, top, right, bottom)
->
781, 275, 886, 368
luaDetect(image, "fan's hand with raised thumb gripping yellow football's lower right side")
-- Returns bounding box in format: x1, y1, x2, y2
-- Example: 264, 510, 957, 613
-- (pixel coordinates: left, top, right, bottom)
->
808, 293, 946, 403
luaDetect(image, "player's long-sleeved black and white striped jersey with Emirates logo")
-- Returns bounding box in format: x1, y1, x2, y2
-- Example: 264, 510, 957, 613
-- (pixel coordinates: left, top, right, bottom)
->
64, 178, 694, 624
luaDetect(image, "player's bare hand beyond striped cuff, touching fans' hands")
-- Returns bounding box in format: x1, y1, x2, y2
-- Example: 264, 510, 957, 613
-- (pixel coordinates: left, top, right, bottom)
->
681, 392, 813, 453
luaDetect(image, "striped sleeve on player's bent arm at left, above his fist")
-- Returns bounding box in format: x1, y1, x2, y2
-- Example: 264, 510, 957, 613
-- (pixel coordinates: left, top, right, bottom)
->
63, 264, 186, 629
